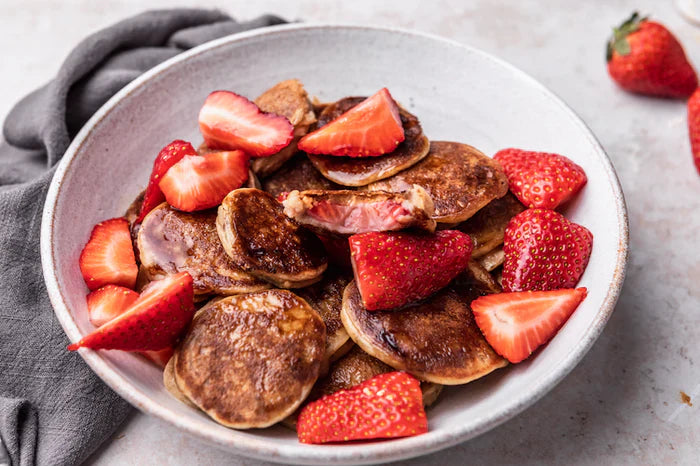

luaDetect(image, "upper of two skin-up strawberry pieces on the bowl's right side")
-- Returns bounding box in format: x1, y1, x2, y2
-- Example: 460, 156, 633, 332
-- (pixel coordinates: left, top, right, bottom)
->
493, 149, 588, 209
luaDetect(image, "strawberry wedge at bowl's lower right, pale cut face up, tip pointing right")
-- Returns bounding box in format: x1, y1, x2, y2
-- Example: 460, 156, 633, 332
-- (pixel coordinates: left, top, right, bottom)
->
471, 288, 587, 363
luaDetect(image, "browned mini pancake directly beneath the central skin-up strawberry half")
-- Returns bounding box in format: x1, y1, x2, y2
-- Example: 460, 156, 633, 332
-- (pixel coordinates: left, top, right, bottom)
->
341, 270, 507, 385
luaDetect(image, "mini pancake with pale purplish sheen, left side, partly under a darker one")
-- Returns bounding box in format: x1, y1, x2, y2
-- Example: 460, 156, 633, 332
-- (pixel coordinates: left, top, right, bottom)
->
137, 202, 270, 297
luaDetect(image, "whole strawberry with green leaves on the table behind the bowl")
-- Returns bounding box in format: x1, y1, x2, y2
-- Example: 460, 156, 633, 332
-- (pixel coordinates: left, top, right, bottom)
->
607, 12, 698, 98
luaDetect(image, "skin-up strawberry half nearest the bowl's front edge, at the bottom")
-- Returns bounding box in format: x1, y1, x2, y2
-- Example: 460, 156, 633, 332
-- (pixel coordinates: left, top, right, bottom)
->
297, 372, 428, 443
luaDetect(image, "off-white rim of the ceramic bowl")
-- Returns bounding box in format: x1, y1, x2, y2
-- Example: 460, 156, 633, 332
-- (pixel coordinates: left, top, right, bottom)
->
40, 23, 629, 464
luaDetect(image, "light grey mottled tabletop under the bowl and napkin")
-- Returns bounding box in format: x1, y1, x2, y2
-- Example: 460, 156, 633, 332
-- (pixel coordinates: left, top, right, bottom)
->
0, 0, 700, 465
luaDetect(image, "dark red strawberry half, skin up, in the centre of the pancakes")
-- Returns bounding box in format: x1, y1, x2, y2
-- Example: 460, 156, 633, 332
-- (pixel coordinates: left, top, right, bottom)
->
349, 230, 473, 311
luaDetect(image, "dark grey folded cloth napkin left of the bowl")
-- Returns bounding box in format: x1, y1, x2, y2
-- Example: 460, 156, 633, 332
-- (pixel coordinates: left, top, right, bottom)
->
0, 9, 284, 466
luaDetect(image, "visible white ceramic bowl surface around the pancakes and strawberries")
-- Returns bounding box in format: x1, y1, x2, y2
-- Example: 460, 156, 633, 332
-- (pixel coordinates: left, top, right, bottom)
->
41, 25, 628, 464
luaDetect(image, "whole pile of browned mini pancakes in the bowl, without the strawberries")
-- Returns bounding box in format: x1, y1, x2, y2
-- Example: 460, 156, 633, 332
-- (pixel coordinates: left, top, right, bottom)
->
127, 80, 524, 429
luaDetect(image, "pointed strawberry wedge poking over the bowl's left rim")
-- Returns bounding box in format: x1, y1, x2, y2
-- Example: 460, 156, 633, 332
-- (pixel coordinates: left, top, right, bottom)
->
68, 272, 195, 351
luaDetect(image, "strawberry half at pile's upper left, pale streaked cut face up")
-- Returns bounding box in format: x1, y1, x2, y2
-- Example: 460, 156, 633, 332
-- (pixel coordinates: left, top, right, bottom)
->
199, 91, 294, 157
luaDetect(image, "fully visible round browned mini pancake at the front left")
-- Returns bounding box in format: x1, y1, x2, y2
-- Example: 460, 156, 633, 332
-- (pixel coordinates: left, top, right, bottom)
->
173, 290, 326, 429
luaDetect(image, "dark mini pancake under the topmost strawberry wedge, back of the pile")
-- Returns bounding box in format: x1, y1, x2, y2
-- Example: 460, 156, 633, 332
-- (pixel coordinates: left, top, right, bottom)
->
309, 97, 430, 186
